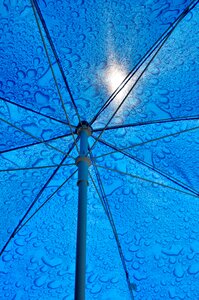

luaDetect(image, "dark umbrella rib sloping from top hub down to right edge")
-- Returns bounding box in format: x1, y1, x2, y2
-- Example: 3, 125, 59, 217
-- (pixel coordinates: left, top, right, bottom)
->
93, 136, 199, 196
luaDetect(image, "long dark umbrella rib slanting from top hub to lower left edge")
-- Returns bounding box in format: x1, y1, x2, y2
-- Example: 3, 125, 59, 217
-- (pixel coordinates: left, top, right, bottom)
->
0, 139, 77, 256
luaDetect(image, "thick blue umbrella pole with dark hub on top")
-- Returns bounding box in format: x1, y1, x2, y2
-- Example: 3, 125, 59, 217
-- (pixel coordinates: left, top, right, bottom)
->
75, 121, 91, 300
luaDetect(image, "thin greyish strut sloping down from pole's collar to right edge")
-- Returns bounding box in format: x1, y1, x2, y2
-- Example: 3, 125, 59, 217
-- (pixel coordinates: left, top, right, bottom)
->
96, 165, 199, 198
